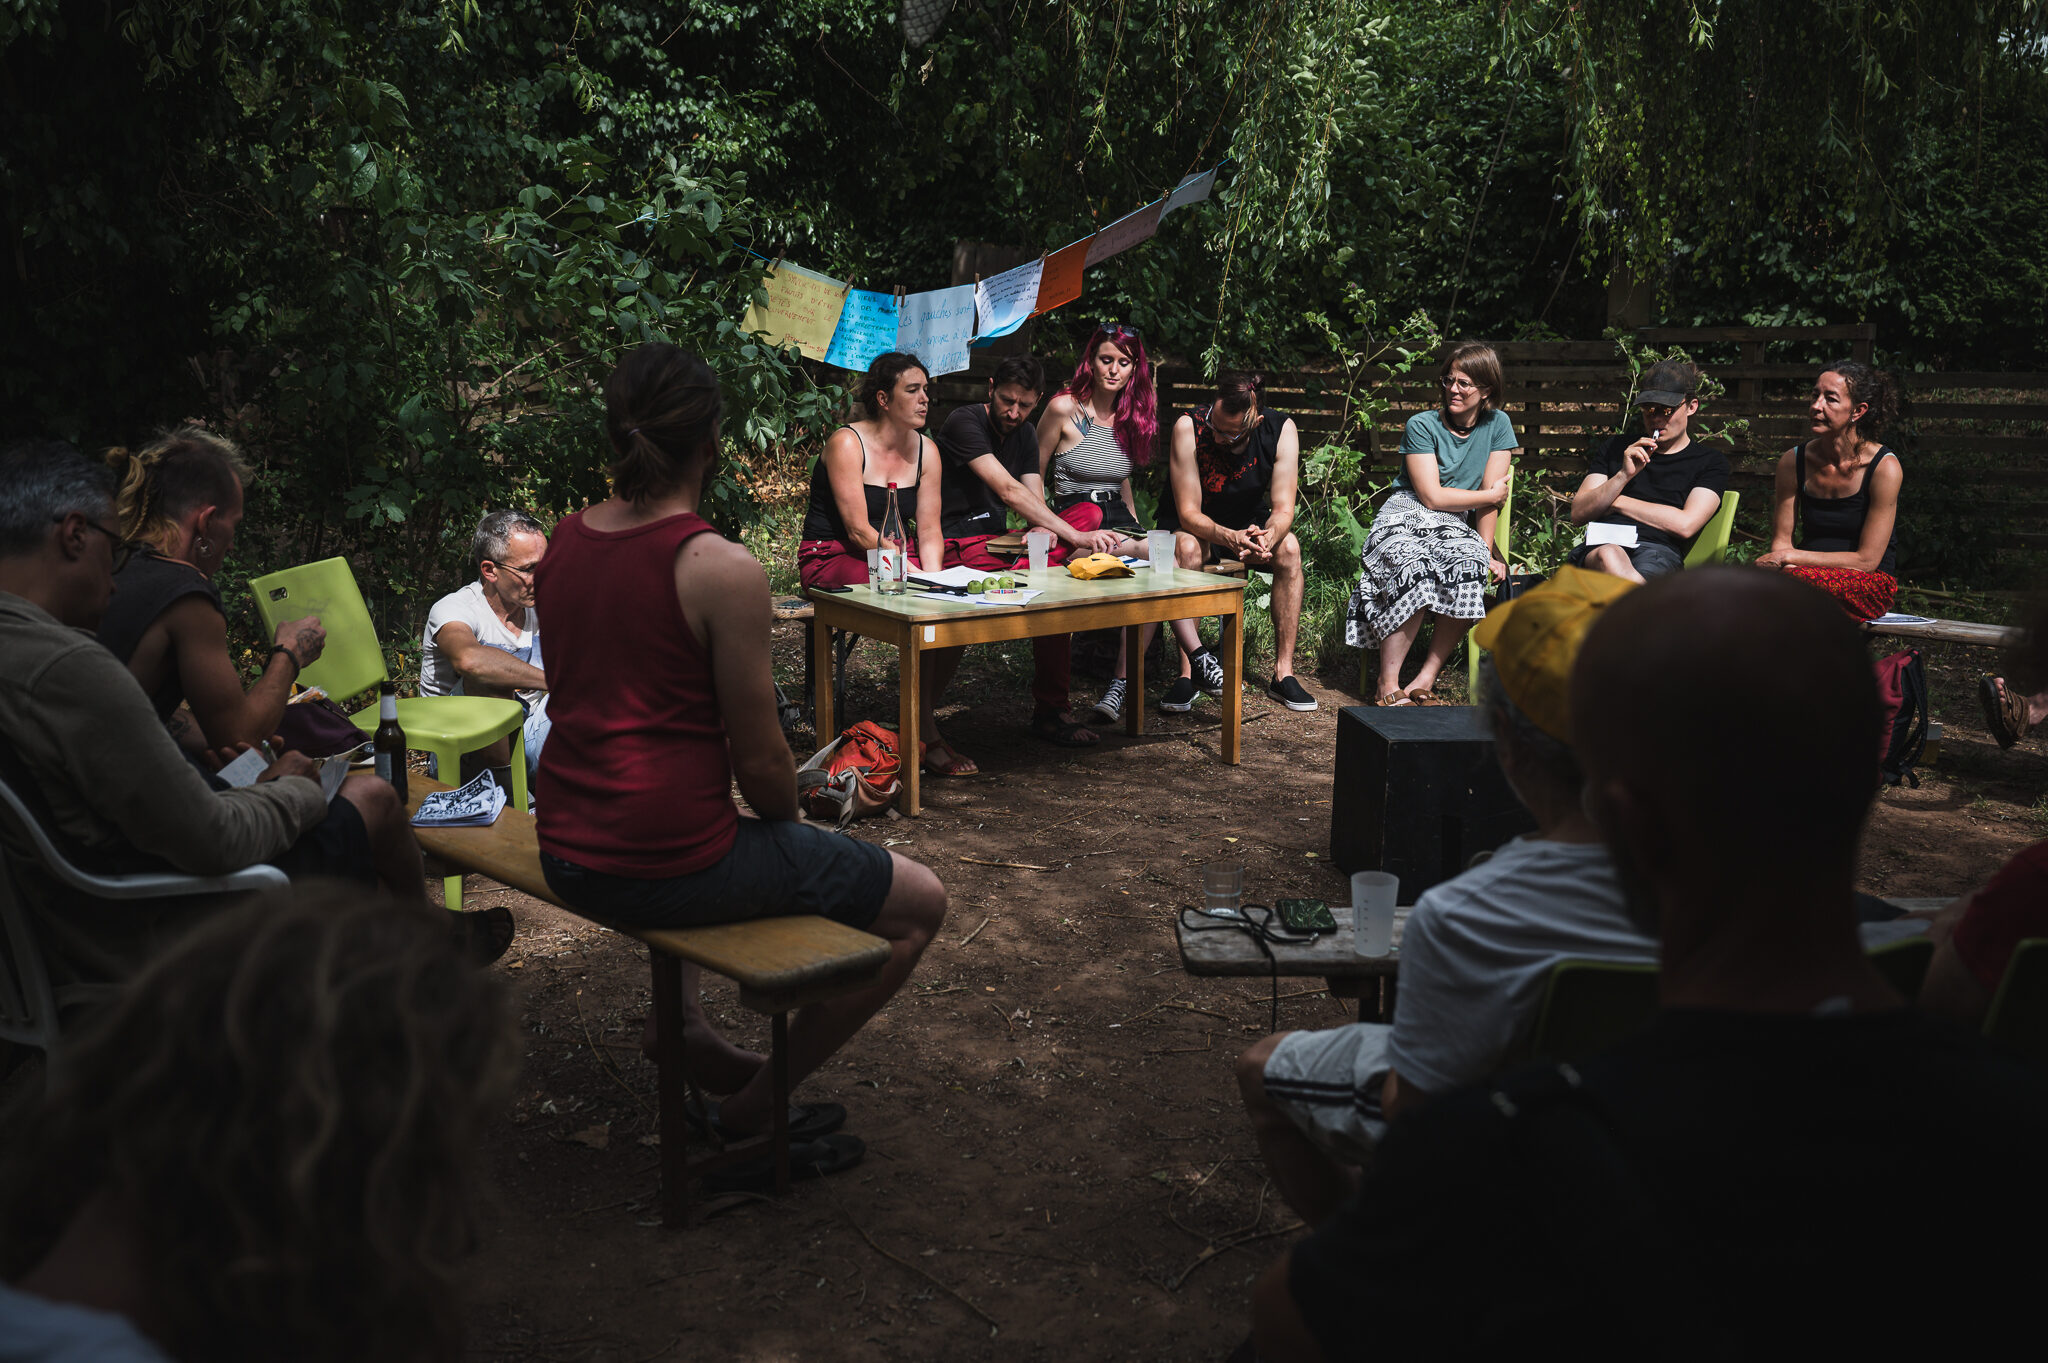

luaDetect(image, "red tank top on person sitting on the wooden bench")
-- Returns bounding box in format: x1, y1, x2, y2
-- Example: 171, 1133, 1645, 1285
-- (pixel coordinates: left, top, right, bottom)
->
532, 512, 739, 880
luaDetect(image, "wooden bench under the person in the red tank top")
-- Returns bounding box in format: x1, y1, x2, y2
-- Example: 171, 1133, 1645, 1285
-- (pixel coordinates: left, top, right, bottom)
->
408, 774, 889, 1226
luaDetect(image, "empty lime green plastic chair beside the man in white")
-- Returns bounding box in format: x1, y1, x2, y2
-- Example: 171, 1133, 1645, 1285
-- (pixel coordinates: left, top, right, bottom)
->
250, 559, 526, 909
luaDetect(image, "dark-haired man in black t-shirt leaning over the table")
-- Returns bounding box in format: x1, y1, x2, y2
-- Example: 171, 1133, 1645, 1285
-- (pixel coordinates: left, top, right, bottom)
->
932, 354, 1118, 747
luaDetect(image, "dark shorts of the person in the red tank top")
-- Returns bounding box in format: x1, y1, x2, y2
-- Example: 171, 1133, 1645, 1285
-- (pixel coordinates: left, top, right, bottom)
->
541, 819, 895, 929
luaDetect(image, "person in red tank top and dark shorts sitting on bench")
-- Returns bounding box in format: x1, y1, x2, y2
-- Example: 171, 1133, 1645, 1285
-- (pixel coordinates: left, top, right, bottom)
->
535, 344, 946, 1175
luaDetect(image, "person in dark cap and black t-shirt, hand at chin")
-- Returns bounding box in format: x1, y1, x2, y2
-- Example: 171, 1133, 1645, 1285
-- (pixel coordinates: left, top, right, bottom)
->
1571, 360, 1729, 581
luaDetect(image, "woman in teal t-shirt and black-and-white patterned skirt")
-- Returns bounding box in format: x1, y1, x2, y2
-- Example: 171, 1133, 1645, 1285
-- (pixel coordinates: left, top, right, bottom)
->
1343, 342, 1520, 706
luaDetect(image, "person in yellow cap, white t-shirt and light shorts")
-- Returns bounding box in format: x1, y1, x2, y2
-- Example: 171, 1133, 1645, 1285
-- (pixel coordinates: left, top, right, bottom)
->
1237, 567, 1657, 1226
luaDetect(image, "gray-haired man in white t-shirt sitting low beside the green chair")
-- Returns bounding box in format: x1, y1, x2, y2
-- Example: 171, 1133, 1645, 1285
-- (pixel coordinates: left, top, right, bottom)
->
420, 512, 549, 778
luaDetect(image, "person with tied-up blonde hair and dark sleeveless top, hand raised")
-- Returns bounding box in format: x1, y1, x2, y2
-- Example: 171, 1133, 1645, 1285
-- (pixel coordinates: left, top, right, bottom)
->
100, 426, 328, 753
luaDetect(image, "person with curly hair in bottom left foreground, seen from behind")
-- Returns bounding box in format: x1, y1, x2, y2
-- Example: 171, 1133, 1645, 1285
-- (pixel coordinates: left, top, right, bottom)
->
0, 882, 516, 1363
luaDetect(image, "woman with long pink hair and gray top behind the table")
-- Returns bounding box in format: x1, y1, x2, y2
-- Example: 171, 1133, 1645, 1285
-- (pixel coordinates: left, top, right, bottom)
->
1038, 321, 1223, 724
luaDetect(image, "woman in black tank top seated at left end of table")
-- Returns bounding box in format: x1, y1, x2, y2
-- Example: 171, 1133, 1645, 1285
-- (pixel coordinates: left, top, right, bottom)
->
797, 350, 979, 776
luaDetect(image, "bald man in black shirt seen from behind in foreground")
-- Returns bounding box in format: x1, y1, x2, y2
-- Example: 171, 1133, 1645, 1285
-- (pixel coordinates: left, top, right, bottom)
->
1253, 569, 2048, 1361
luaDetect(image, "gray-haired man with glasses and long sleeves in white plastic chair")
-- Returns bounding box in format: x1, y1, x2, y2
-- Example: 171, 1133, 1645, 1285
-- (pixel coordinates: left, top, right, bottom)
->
0, 440, 415, 982
